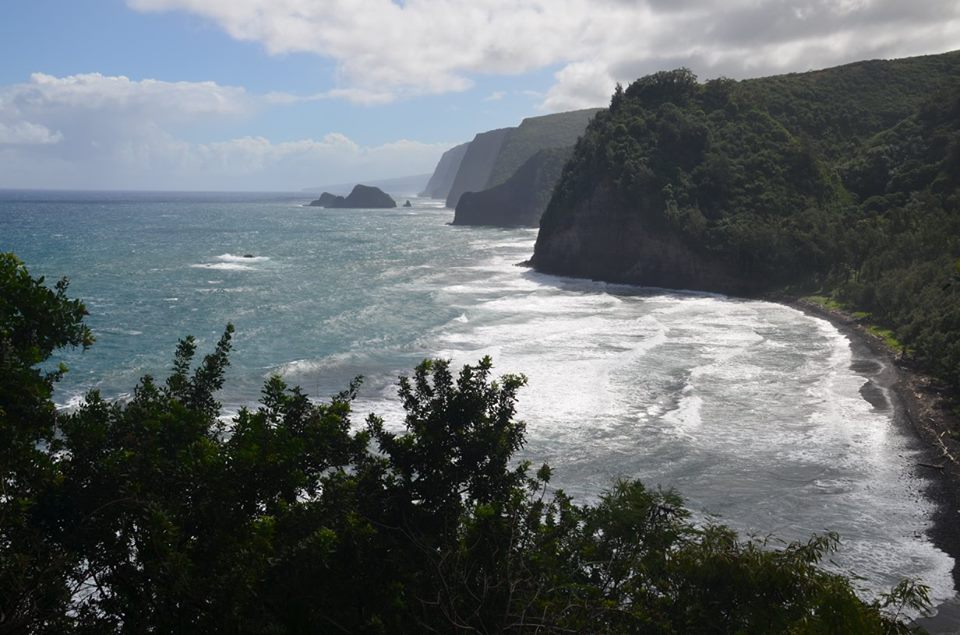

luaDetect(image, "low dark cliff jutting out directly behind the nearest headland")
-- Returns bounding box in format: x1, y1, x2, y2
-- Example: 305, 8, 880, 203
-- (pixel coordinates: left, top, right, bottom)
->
453, 146, 573, 227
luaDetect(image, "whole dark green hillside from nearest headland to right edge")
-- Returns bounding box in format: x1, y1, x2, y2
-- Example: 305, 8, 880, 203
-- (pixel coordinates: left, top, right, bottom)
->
533, 53, 960, 390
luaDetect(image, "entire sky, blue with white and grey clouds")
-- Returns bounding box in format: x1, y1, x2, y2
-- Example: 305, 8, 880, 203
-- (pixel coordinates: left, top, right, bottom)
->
0, 0, 960, 191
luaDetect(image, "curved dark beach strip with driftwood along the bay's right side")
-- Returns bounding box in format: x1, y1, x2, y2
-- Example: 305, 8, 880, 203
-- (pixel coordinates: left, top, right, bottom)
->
784, 297, 960, 633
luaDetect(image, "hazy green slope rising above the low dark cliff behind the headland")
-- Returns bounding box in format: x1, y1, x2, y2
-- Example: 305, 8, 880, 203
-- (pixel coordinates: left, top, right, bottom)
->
486, 108, 601, 188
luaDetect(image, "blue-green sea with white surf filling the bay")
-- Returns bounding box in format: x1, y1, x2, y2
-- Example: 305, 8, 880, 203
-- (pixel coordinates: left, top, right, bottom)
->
0, 193, 953, 600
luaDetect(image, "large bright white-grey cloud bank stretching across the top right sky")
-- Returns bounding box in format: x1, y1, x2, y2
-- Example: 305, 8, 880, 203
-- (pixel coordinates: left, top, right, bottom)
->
127, 0, 960, 110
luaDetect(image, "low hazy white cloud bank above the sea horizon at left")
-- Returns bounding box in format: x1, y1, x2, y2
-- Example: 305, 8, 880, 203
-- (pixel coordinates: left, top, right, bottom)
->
0, 73, 452, 190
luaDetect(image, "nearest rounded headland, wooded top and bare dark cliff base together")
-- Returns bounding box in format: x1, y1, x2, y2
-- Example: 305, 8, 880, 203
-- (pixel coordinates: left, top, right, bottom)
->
532, 70, 841, 294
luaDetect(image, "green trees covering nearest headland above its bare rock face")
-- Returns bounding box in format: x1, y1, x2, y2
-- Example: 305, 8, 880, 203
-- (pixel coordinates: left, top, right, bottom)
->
541, 70, 844, 290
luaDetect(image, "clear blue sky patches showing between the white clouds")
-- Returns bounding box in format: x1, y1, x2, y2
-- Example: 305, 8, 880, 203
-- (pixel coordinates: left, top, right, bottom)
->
0, 0, 552, 144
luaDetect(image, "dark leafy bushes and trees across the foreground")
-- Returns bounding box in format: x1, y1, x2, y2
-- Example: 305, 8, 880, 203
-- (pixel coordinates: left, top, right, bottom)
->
0, 255, 927, 634
